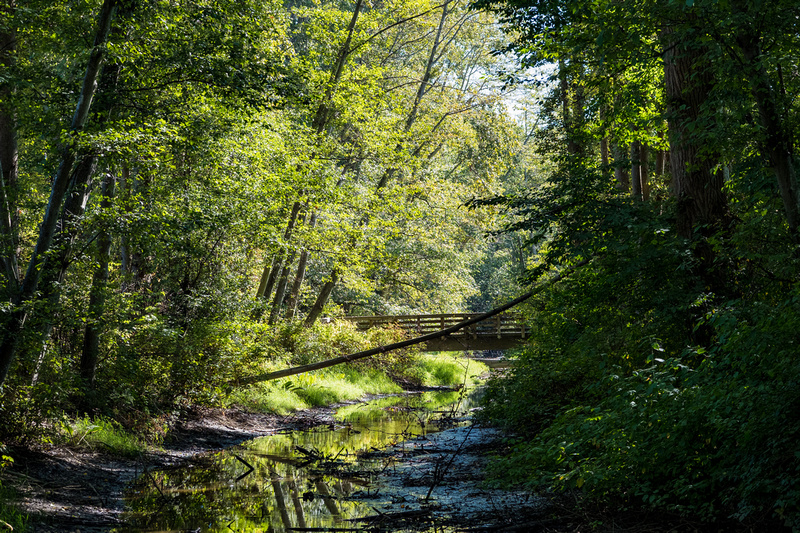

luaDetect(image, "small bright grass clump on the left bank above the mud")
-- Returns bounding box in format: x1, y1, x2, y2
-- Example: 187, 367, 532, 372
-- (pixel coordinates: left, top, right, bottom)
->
60, 416, 147, 457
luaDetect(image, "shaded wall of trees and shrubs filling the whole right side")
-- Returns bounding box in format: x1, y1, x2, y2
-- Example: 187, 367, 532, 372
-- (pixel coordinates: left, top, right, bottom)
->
456, 0, 800, 529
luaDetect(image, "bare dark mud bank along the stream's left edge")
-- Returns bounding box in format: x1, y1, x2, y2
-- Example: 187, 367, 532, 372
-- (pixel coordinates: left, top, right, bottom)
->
3, 406, 350, 533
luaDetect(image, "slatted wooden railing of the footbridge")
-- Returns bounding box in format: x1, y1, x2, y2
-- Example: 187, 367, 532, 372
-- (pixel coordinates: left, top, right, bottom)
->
345, 313, 527, 339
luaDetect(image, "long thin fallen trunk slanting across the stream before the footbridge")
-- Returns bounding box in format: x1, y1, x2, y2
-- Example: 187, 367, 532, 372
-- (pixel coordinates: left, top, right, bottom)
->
236, 259, 589, 385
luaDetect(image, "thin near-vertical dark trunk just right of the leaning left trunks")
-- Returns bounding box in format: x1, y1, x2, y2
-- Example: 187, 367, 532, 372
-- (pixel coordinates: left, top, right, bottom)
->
80, 172, 115, 387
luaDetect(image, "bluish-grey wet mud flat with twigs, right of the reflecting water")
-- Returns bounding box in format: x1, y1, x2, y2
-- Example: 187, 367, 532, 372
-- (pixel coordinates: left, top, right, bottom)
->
353, 425, 554, 532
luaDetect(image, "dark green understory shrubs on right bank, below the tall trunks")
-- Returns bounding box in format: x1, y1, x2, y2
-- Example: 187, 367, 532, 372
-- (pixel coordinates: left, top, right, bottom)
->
483, 130, 800, 528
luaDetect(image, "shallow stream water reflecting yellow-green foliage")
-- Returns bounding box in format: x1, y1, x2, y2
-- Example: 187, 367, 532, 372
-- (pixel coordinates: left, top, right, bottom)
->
120, 392, 474, 533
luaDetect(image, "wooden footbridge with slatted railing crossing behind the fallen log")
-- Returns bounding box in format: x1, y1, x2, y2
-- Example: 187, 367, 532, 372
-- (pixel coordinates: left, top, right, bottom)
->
345, 313, 527, 352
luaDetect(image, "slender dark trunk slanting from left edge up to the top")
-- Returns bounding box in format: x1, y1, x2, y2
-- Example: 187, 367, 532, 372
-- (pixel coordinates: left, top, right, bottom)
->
0, 0, 116, 385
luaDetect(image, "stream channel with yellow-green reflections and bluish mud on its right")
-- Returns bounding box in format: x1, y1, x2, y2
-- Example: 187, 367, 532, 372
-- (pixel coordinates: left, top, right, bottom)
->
118, 389, 546, 533
